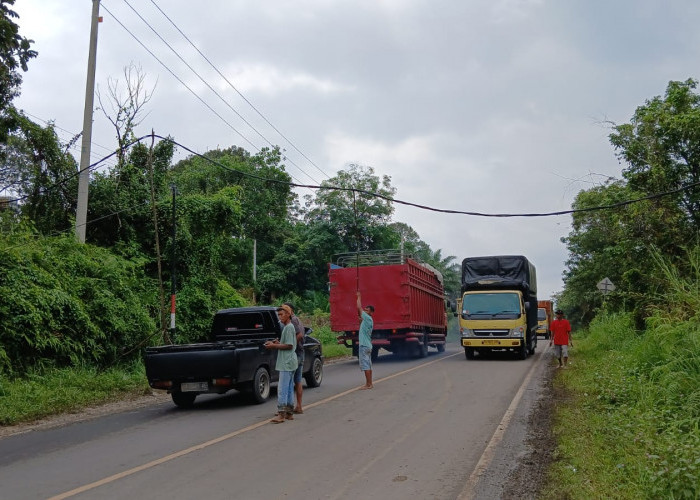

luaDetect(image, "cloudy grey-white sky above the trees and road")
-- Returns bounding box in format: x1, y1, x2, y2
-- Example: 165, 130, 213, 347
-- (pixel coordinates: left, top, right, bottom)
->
9, 0, 700, 299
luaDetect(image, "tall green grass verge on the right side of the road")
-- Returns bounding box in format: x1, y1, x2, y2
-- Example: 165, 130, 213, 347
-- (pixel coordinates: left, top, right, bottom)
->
541, 315, 700, 500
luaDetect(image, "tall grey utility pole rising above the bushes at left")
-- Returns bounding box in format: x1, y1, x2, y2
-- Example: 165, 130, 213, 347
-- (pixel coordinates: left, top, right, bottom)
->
75, 0, 101, 243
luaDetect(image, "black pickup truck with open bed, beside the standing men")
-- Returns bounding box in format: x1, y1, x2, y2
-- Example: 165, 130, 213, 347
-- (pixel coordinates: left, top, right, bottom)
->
144, 306, 323, 407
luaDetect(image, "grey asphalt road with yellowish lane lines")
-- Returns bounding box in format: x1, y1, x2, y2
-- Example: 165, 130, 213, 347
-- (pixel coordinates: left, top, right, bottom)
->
0, 340, 547, 500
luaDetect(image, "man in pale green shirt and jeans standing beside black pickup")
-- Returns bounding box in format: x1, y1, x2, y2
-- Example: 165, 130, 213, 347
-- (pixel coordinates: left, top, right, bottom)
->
265, 305, 298, 424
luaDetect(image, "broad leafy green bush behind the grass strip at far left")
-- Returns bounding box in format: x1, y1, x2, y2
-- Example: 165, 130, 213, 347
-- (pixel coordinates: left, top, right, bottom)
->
0, 228, 154, 374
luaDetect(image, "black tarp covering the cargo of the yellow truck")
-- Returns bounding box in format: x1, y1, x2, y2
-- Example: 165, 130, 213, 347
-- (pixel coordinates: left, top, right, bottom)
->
462, 255, 537, 295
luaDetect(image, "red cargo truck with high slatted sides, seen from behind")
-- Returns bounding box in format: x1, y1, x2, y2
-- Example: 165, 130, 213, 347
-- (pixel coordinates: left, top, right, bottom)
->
328, 250, 447, 359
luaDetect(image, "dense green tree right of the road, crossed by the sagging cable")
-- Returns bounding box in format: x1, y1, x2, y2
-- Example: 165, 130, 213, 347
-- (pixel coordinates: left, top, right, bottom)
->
560, 80, 700, 327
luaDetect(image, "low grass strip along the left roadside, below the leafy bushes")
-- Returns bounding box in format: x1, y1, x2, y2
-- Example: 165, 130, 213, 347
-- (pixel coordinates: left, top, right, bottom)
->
0, 363, 148, 425
